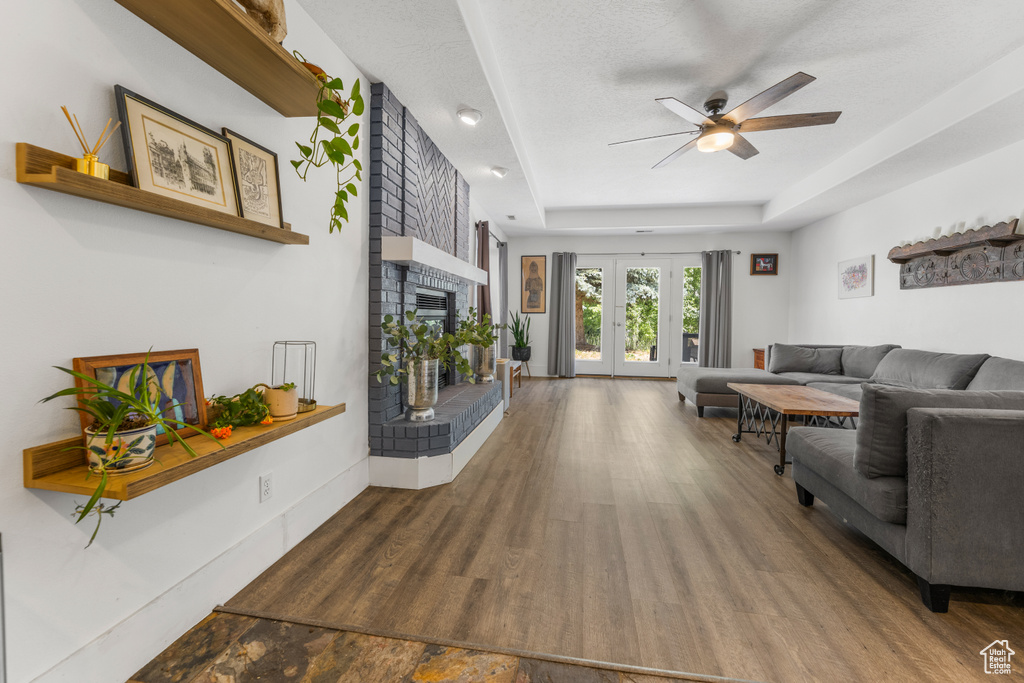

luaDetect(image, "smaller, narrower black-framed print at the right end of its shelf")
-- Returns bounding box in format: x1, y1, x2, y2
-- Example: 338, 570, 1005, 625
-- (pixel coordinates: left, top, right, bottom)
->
221, 128, 284, 227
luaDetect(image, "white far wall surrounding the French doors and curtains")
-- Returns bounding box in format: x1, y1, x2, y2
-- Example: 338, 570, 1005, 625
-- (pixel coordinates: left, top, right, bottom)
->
506, 232, 792, 376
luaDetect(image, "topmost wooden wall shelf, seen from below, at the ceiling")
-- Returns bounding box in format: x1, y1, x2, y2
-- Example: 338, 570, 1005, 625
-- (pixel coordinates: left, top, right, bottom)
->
117, 0, 319, 117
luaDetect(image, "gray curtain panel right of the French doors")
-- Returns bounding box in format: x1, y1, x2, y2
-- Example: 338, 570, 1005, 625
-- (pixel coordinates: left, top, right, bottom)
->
697, 250, 732, 368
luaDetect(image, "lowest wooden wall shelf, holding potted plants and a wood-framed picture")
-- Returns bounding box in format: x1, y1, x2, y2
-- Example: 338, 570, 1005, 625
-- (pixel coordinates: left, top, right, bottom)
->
24, 403, 345, 501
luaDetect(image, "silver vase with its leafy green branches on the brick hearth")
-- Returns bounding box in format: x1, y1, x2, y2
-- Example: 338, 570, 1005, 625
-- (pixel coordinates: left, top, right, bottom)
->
374, 310, 472, 422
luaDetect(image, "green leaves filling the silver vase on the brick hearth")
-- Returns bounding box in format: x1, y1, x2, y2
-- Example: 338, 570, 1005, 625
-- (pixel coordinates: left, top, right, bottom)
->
374, 310, 473, 384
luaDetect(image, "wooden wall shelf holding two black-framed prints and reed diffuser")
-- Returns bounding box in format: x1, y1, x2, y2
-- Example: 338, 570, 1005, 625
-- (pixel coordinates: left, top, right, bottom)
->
16, 142, 309, 245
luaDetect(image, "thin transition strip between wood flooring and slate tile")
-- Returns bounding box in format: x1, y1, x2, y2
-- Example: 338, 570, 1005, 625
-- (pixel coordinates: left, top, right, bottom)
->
214, 605, 753, 683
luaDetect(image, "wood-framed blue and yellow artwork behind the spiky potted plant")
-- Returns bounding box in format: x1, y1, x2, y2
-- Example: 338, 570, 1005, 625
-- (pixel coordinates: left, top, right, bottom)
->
72, 348, 207, 445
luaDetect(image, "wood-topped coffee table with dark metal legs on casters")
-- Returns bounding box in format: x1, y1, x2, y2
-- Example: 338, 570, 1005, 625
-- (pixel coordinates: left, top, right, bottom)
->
727, 382, 860, 476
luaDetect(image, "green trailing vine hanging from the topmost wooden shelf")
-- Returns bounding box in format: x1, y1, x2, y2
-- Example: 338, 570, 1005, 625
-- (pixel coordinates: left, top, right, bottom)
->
292, 51, 366, 232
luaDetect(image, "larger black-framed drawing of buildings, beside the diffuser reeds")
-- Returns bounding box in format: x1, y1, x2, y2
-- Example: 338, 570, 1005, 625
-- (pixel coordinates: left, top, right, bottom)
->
114, 85, 239, 216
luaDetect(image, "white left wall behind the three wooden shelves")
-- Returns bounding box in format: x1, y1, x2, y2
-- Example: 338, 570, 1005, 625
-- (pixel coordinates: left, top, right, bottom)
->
0, 0, 370, 683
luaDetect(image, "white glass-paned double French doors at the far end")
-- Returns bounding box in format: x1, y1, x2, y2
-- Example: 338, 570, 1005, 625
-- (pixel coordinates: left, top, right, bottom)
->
575, 257, 682, 377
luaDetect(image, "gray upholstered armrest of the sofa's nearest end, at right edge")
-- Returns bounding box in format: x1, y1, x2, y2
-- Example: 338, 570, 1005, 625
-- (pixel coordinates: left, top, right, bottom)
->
906, 408, 1024, 591
